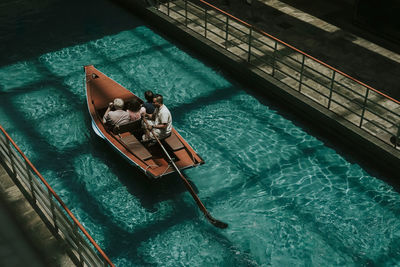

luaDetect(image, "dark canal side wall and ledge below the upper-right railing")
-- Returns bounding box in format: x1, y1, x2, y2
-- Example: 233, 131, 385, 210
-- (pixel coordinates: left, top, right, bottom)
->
113, 0, 400, 177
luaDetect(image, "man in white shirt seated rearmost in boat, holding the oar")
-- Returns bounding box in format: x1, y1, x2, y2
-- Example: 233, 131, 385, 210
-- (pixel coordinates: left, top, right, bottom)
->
142, 95, 172, 141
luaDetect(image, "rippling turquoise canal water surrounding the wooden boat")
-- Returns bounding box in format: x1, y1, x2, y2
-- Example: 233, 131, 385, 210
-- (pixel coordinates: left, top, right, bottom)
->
0, 2, 400, 266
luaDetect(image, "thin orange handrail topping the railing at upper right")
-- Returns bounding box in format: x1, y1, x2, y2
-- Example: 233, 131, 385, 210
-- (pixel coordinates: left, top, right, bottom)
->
197, 0, 400, 104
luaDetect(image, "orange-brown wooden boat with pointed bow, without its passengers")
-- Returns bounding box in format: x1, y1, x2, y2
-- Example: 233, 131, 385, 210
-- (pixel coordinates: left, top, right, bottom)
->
84, 65, 204, 179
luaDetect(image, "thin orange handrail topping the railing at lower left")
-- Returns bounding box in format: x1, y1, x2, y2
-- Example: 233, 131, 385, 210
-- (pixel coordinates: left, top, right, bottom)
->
0, 125, 115, 267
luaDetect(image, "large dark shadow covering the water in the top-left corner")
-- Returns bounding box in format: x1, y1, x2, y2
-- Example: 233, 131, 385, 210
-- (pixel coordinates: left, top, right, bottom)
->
0, 0, 142, 66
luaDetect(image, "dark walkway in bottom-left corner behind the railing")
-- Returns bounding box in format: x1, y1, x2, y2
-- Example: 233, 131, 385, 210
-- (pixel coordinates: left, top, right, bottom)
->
0, 164, 75, 267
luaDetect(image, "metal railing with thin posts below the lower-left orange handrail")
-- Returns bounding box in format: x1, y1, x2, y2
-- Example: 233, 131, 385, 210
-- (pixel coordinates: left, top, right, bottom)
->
0, 125, 114, 267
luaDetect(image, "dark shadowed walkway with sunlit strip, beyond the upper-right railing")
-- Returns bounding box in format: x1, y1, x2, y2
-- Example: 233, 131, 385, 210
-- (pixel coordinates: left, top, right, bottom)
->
210, 0, 400, 100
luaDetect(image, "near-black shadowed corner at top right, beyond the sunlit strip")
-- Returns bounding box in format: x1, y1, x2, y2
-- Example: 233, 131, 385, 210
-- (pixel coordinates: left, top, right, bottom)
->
281, 0, 400, 50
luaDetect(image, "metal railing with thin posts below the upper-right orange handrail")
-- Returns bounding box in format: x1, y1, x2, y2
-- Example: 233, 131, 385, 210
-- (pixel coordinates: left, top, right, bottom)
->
155, 0, 400, 147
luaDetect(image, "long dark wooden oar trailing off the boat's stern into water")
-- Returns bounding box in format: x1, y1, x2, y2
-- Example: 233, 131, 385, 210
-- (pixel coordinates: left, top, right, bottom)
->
143, 118, 228, 229
